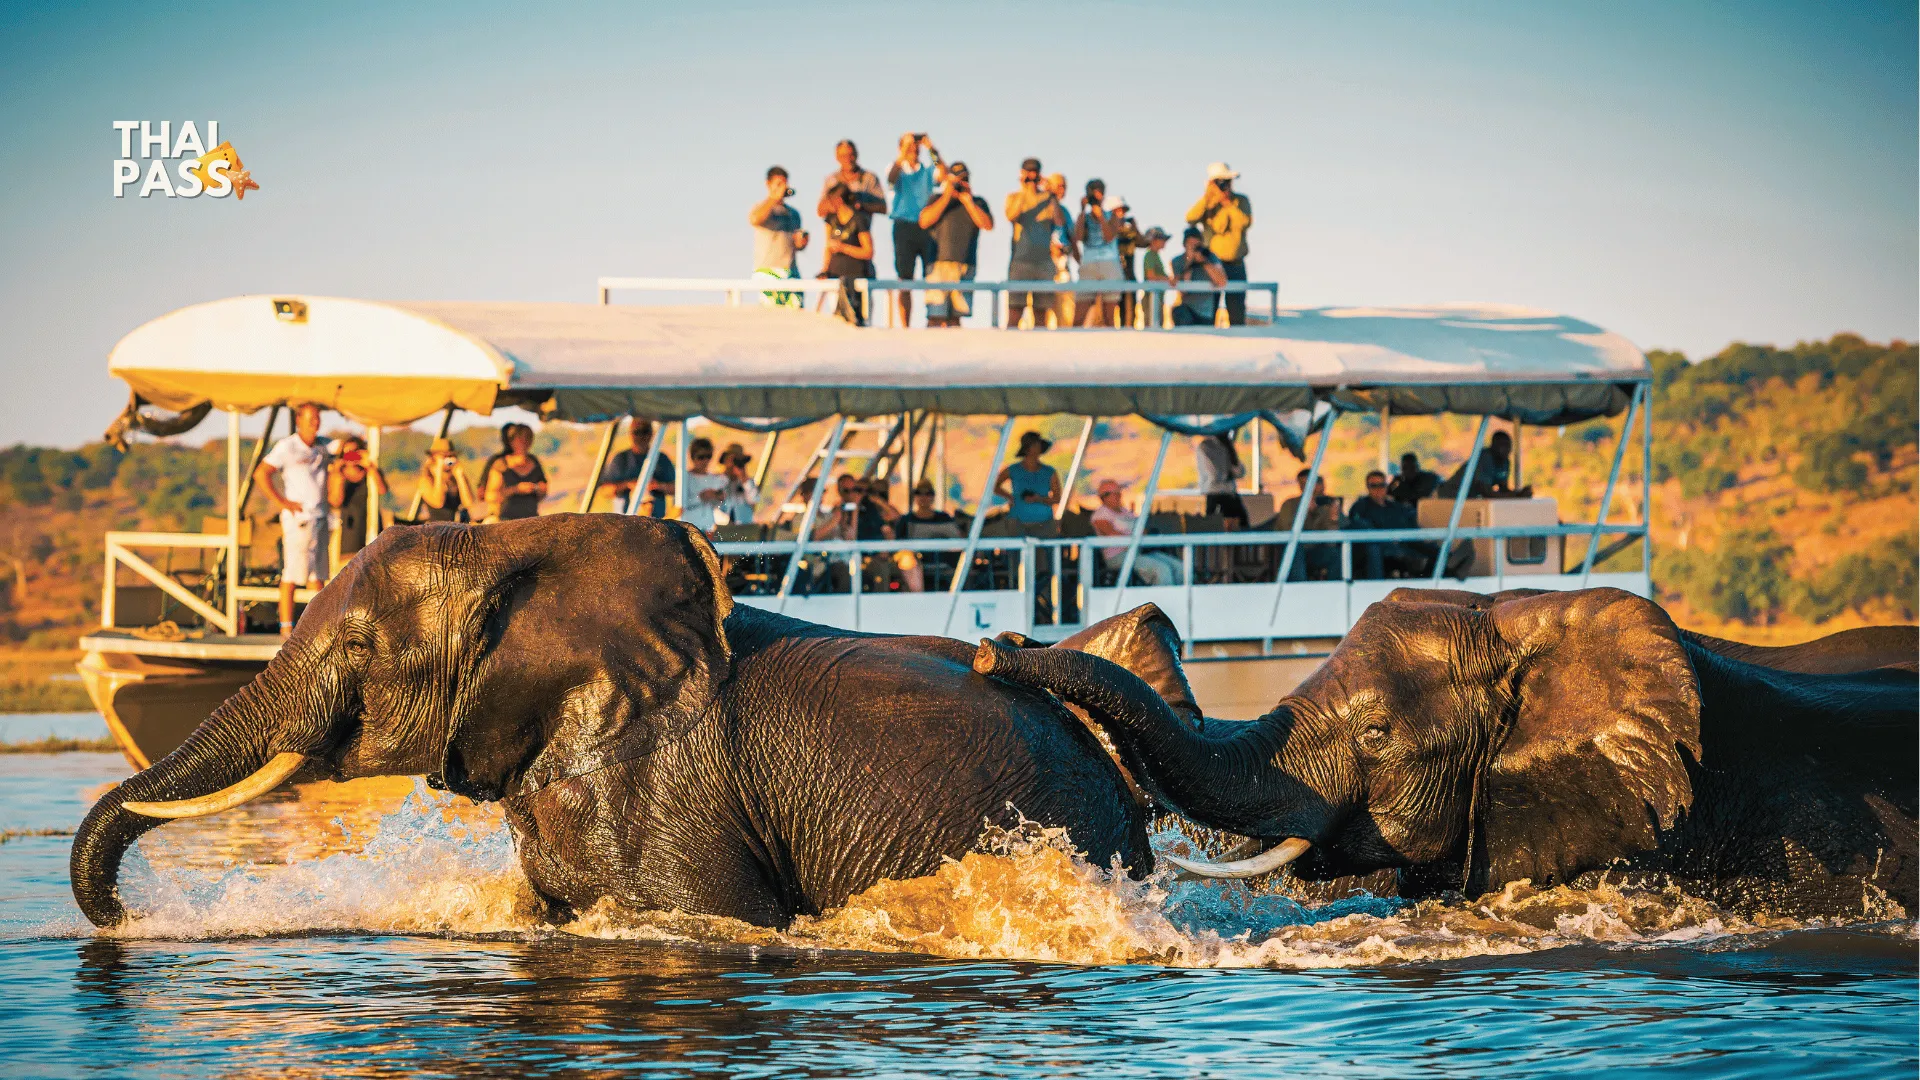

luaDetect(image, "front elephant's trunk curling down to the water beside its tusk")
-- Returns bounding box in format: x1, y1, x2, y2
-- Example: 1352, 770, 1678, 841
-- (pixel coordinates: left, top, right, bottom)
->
67, 678, 294, 926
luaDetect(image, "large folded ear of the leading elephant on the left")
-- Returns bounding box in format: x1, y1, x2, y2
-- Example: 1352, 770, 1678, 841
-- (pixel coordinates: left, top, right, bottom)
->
451, 515, 733, 794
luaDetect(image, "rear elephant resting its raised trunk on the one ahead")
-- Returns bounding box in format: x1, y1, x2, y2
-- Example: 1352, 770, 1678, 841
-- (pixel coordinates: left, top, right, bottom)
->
973, 588, 1920, 915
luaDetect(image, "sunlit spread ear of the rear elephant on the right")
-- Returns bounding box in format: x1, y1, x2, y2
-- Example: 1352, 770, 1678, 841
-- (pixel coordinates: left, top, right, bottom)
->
1467, 588, 1701, 892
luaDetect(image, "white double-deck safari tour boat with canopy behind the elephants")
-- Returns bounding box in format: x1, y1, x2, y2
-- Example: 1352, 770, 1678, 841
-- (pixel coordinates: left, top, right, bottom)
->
79, 279, 1651, 769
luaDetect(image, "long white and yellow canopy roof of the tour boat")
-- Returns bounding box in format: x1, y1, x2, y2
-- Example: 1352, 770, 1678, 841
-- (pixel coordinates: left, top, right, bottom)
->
108, 296, 1651, 425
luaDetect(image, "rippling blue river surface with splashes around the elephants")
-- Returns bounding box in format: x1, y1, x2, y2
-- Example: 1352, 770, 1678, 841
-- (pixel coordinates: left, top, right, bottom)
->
0, 719, 1920, 1080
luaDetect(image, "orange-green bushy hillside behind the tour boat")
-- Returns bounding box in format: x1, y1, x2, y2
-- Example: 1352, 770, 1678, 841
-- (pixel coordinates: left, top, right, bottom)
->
0, 334, 1920, 651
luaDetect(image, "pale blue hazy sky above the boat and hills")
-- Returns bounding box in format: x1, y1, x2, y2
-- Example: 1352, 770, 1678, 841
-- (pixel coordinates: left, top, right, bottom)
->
0, 0, 1920, 446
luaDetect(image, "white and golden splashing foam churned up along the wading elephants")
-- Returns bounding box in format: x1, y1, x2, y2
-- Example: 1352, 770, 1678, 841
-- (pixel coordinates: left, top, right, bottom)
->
101, 784, 1914, 969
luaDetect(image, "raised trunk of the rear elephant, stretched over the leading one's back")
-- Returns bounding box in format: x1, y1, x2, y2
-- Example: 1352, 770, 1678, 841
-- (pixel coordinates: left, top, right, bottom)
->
973, 642, 1331, 840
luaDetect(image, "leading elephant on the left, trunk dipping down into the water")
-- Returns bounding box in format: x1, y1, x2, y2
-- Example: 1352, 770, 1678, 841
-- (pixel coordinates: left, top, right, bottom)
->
71, 515, 1158, 926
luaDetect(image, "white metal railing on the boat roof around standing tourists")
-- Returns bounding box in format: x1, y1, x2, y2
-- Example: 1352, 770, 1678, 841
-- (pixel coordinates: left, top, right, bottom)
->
599, 277, 1281, 329
